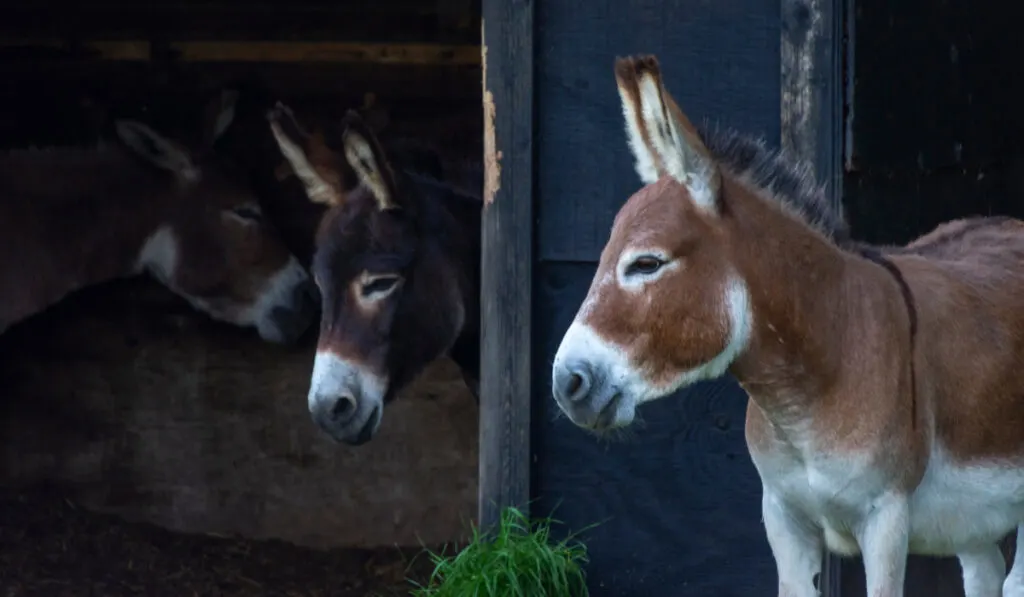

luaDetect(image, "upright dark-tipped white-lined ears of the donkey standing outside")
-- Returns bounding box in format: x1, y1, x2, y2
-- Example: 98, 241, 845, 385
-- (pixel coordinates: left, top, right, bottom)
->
615, 55, 721, 209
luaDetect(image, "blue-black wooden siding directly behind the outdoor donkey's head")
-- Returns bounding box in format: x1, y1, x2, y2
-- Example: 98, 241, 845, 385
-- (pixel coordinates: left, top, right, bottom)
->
531, 0, 780, 597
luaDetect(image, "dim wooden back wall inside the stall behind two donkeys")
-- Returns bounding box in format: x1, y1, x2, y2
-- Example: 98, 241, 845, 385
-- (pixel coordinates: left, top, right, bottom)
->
0, 0, 482, 547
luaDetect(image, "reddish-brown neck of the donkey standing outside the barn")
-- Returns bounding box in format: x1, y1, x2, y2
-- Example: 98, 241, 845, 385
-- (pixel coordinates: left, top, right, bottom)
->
730, 182, 907, 438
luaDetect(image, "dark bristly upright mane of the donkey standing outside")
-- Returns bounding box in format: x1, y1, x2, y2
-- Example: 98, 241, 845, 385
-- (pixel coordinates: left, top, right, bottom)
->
698, 124, 851, 247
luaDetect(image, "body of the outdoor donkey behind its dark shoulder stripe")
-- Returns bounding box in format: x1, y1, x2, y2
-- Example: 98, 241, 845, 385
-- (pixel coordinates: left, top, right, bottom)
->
892, 217, 1024, 557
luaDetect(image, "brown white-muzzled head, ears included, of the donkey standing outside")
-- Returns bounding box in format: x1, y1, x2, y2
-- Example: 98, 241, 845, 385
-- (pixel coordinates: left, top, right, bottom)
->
552, 56, 752, 430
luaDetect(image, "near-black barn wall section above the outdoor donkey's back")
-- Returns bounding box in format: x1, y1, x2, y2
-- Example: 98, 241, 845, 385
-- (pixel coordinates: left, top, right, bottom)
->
842, 0, 1024, 597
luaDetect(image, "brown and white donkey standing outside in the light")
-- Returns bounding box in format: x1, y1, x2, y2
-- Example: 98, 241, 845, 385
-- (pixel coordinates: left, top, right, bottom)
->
552, 56, 1024, 597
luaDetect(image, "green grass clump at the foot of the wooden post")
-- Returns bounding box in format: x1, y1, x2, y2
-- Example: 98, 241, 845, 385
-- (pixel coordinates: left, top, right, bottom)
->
412, 508, 588, 597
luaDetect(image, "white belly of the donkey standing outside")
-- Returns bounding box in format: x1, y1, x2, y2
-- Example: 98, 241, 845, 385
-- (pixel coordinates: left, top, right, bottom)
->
910, 450, 1024, 555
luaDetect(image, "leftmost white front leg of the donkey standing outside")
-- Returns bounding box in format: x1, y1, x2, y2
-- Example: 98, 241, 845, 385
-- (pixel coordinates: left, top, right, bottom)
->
761, 487, 822, 597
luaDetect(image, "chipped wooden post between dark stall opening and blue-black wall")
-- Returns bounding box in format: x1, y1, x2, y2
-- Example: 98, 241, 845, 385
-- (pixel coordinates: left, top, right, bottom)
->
479, 0, 534, 528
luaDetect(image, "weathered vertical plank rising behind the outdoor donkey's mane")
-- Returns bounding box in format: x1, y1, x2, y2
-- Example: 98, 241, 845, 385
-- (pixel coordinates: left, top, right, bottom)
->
781, 0, 839, 597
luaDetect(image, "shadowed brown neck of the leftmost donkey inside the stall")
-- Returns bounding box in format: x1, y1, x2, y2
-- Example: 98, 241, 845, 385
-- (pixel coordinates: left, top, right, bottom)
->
0, 144, 174, 331
